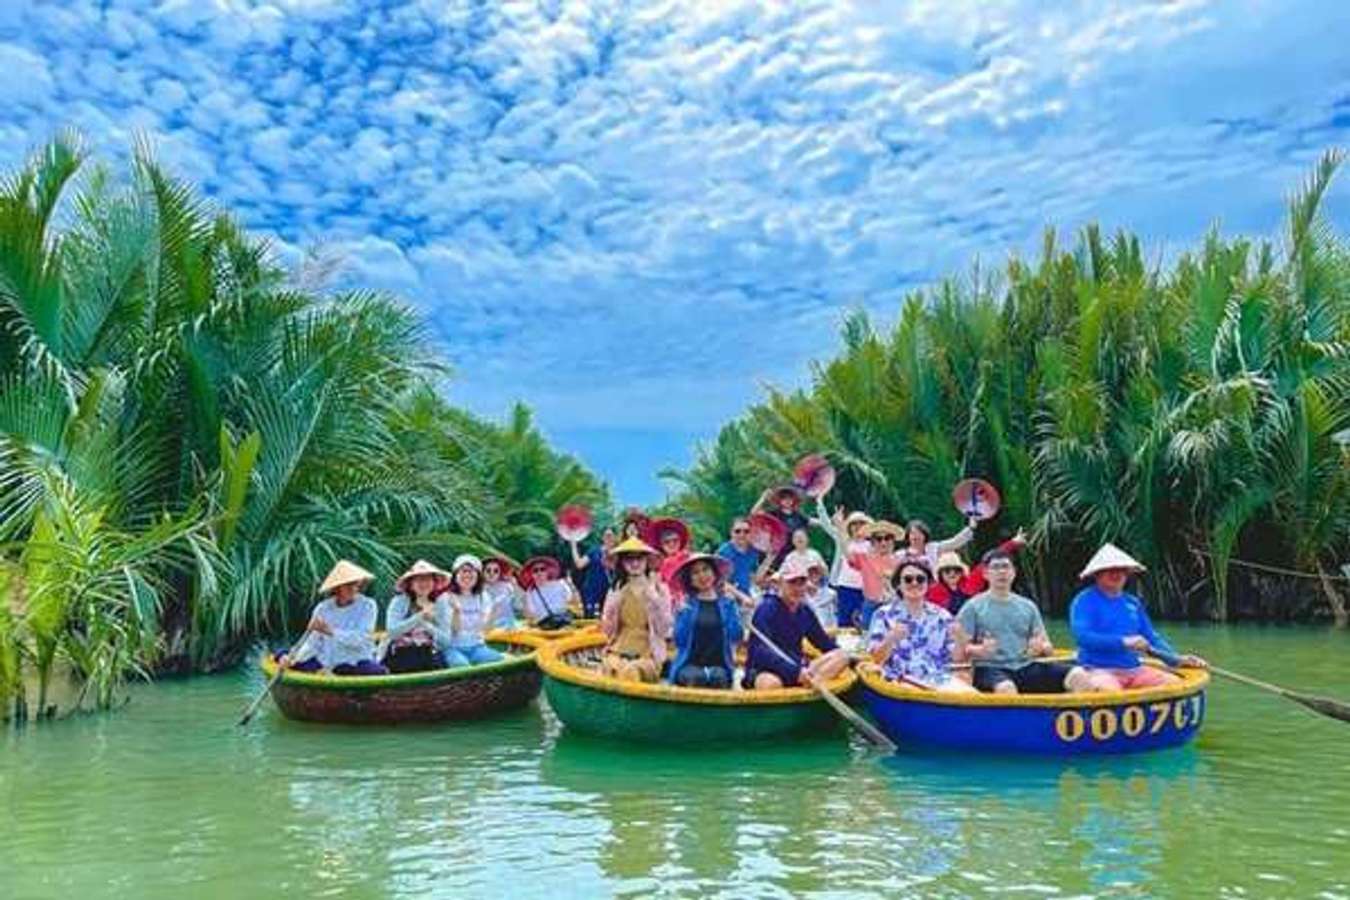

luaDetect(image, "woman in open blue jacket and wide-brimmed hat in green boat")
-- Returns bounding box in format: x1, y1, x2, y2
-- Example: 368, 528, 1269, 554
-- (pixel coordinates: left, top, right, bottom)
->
670, 553, 744, 688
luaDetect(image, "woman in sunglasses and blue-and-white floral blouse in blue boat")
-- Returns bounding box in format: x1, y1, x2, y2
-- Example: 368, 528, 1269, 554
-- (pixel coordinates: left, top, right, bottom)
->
867, 557, 975, 694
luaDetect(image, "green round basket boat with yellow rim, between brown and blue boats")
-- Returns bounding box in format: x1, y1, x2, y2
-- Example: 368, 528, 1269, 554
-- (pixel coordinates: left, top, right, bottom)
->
539, 631, 857, 746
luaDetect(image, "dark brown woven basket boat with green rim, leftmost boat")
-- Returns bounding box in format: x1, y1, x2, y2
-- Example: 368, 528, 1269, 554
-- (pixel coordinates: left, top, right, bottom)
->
262, 631, 543, 725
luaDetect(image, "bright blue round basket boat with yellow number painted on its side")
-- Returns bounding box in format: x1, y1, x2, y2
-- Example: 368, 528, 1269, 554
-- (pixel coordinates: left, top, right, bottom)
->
860, 663, 1210, 756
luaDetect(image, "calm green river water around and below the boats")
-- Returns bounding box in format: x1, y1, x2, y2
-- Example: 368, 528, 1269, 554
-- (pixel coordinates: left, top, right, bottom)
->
0, 626, 1350, 900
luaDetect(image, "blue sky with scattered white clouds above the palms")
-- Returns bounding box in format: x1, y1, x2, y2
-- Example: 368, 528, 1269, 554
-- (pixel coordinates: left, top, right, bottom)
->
0, 0, 1350, 502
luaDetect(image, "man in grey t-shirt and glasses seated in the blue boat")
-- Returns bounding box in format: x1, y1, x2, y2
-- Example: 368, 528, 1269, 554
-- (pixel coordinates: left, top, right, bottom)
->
956, 549, 1073, 694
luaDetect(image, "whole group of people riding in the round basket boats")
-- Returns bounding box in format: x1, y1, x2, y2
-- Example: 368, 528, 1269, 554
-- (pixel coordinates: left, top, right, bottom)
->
279, 484, 1206, 694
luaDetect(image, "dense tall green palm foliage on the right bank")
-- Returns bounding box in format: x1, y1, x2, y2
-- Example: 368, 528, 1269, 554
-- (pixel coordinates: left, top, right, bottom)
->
667, 154, 1350, 623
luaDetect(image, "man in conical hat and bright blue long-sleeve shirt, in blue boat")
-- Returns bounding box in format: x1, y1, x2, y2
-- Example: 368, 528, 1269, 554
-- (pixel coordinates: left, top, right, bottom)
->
1068, 544, 1206, 691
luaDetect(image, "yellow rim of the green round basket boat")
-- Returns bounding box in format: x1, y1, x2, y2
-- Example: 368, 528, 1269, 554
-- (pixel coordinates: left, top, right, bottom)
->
539, 631, 857, 707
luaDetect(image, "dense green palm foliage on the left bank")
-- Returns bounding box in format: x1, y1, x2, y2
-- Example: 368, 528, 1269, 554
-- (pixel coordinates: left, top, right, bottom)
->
0, 136, 606, 707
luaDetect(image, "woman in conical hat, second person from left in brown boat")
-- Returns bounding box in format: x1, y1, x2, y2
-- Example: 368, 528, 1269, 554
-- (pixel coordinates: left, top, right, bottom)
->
385, 560, 451, 673
